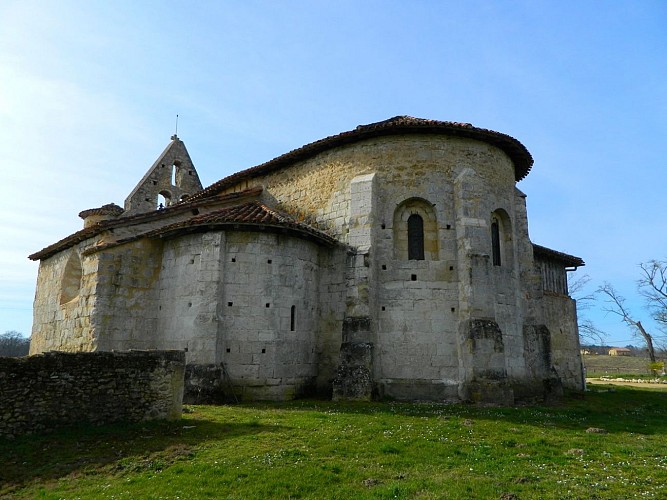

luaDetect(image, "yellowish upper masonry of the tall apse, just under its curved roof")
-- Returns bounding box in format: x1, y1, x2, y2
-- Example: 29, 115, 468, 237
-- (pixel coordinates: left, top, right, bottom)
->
230, 134, 515, 243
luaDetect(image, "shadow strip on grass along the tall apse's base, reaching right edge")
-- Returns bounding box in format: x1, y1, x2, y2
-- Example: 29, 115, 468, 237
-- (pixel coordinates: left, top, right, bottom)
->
235, 386, 667, 435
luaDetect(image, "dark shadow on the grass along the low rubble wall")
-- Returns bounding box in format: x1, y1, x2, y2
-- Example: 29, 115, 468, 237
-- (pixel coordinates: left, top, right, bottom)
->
0, 410, 281, 498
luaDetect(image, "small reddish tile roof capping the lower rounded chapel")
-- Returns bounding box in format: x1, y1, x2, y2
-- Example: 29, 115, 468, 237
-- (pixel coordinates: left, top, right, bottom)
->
143, 201, 337, 245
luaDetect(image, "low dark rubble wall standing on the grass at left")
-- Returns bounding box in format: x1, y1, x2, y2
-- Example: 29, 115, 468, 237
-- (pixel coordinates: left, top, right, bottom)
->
0, 351, 185, 437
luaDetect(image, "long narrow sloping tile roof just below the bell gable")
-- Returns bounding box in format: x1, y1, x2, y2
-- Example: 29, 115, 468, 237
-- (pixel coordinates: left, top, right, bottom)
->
28, 188, 262, 260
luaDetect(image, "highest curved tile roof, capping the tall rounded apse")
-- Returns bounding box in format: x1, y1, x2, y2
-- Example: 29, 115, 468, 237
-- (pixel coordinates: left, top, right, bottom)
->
191, 116, 533, 204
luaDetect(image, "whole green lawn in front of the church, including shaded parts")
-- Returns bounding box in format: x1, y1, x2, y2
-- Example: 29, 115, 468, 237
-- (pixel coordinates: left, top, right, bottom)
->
0, 386, 667, 499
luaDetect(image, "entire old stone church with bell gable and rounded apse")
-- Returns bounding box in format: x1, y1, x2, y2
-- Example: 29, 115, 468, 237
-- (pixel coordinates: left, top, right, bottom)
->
30, 116, 584, 404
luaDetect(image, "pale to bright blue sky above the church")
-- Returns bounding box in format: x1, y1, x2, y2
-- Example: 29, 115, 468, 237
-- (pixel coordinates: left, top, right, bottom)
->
0, 0, 667, 345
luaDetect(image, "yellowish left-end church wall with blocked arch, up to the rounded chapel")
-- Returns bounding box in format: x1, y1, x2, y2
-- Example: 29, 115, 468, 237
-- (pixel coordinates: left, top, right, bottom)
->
30, 239, 167, 354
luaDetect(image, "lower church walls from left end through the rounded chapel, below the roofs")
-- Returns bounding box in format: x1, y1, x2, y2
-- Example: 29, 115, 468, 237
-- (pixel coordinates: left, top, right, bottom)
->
31, 225, 345, 399
